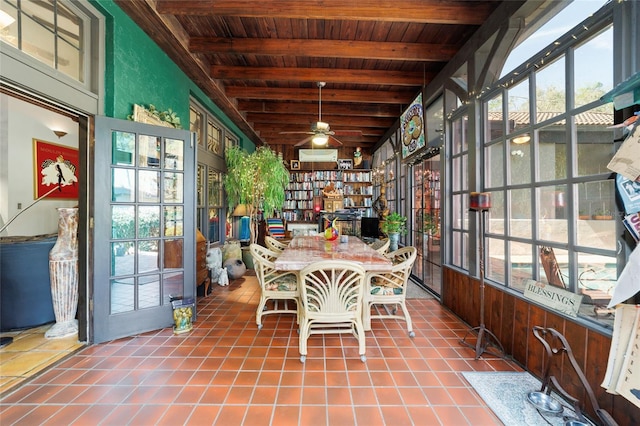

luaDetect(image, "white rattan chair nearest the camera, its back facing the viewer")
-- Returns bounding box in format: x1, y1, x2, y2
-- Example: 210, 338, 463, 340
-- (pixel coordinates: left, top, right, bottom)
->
299, 260, 367, 362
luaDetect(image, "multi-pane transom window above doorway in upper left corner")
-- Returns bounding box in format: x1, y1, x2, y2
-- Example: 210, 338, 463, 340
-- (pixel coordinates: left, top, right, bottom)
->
0, 0, 91, 83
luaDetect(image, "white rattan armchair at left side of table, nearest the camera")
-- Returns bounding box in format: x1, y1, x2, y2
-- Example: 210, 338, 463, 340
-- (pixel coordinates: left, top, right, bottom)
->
249, 244, 300, 330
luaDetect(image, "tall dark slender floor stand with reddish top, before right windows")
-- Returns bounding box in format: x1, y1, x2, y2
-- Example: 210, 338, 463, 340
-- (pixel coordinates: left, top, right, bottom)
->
461, 192, 504, 360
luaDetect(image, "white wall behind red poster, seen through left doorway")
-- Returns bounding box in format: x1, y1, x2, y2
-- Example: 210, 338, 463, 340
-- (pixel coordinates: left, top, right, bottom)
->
0, 94, 79, 236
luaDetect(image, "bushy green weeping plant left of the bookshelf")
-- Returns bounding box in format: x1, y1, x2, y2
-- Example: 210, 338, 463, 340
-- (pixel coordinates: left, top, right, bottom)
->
224, 146, 289, 243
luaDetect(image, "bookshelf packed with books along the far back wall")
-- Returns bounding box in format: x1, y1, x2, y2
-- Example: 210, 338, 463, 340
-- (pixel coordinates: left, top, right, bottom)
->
282, 169, 373, 222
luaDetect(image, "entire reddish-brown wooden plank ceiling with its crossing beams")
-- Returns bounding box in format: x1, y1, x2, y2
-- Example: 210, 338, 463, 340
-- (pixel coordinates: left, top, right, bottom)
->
116, 0, 501, 152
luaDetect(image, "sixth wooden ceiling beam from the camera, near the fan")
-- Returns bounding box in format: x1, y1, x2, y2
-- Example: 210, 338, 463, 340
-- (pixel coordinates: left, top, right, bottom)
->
246, 112, 397, 129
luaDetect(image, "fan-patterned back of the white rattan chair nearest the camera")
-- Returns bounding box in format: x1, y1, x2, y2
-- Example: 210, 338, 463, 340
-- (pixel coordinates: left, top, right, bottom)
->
300, 260, 366, 322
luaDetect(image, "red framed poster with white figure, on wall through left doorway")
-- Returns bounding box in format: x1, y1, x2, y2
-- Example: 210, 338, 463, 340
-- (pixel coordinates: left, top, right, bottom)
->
33, 138, 79, 199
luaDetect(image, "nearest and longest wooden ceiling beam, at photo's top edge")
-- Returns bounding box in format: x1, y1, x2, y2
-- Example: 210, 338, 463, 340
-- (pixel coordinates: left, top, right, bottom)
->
156, 0, 494, 25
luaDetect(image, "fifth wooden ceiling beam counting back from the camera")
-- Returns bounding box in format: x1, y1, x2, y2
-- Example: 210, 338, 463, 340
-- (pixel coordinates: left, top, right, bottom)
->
238, 99, 402, 118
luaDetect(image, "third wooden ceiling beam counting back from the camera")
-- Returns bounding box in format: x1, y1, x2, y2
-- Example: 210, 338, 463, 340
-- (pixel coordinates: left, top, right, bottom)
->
211, 65, 435, 87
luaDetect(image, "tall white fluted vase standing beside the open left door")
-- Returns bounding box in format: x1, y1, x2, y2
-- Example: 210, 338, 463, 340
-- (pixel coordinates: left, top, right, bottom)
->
44, 207, 78, 339
